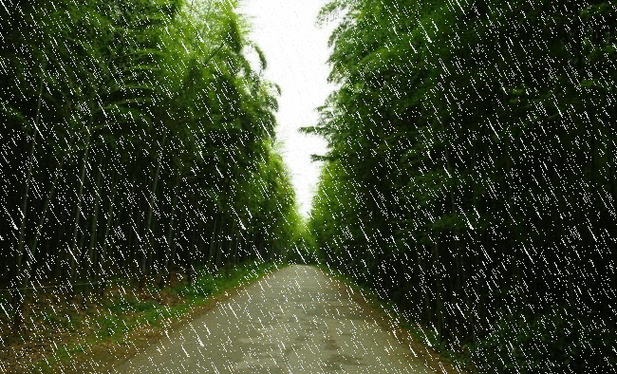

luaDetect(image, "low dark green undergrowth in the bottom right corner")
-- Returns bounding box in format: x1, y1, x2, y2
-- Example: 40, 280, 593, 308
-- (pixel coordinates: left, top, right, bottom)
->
473, 307, 617, 374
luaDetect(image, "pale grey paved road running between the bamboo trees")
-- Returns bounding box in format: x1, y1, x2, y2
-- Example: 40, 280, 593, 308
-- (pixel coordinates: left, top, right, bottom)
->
112, 266, 433, 374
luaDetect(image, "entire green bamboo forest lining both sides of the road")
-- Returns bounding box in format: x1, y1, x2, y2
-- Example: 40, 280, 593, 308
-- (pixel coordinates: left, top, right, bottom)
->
0, 0, 617, 374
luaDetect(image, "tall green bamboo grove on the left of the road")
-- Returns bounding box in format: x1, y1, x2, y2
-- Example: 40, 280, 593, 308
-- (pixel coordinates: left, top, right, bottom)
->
0, 0, 299, 328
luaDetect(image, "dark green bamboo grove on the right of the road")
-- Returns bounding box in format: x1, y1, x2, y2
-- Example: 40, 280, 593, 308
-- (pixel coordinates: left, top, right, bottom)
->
305, 0, 617, 373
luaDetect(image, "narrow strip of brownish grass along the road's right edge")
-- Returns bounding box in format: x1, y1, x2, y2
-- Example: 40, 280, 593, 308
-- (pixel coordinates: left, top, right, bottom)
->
318, 264, 472, 374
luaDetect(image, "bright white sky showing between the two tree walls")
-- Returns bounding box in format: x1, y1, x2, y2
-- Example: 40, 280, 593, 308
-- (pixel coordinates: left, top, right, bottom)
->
239, 0, 335, 217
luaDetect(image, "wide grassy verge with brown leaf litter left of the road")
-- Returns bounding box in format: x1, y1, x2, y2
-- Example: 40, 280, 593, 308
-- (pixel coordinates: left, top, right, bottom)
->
0, 262, 282, 374
